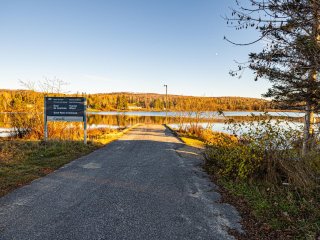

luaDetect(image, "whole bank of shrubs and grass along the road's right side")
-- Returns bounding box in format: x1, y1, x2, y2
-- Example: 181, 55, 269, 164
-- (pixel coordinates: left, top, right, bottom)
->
171, 125, 320, 240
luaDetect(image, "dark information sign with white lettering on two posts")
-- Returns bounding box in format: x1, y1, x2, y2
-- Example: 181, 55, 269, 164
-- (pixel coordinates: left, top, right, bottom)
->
44, 97, 87, 144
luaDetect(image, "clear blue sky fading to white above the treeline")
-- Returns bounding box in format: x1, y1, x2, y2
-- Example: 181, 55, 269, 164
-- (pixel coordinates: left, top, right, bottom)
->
0, 0, 270, 97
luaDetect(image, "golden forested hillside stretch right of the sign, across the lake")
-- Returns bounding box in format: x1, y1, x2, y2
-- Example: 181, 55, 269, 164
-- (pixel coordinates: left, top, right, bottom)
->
88, 92, 273, 111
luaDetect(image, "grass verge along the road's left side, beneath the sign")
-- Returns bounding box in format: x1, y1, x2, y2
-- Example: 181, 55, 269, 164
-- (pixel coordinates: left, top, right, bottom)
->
0, 124, 139, 197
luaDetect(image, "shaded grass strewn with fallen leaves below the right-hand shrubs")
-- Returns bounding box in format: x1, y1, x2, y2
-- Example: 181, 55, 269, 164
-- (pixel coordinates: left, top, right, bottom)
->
211, 173, 320, 240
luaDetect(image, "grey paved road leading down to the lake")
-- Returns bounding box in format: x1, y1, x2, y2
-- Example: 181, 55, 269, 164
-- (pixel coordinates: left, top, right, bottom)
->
0, 125, 241, 240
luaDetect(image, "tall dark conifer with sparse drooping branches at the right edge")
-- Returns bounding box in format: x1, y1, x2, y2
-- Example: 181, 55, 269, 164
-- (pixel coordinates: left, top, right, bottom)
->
226, 0, 320, 154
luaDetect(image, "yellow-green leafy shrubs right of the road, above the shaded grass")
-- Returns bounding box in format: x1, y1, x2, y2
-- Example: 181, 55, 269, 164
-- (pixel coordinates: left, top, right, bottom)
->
204, 117, 320, 190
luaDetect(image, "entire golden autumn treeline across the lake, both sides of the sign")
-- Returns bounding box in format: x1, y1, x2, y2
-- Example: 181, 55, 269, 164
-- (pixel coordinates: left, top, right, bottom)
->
0, 90, 276, 112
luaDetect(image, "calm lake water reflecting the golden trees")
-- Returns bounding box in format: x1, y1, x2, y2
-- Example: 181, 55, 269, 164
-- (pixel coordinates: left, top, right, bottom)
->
0, 111, 310, 137
